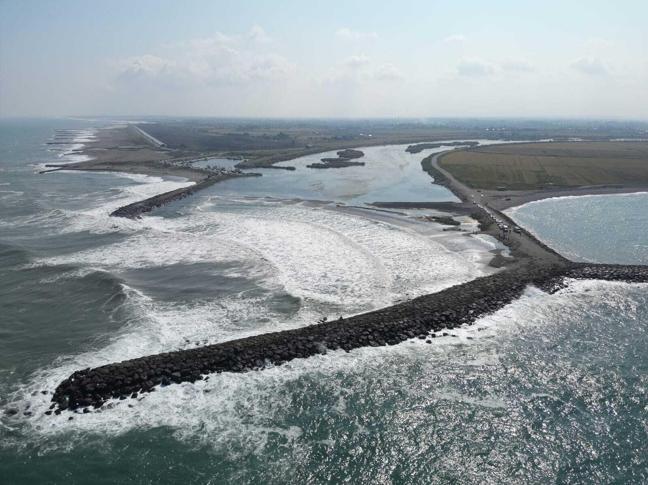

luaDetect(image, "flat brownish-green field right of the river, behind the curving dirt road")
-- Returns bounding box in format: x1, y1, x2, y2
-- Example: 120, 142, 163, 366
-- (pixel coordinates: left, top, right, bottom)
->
439, 142, 648, 190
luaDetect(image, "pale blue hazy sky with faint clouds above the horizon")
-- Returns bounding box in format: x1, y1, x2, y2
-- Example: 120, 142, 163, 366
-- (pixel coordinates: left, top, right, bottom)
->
0, 0, 648, 120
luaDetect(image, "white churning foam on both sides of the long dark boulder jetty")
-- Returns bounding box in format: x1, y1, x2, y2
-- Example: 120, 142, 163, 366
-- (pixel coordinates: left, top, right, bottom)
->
14, 141, 636, 451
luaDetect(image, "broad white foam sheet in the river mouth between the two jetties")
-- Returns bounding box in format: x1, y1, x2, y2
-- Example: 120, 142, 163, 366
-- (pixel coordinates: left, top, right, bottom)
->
40, 198, 486, 308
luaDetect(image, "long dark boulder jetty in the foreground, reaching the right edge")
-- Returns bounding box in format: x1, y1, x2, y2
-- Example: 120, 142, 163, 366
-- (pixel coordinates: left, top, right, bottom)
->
47, 262, 648, 414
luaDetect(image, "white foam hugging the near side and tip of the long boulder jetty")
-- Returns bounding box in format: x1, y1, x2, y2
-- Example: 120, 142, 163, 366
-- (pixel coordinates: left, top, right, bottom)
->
7, 274, 639, 453
